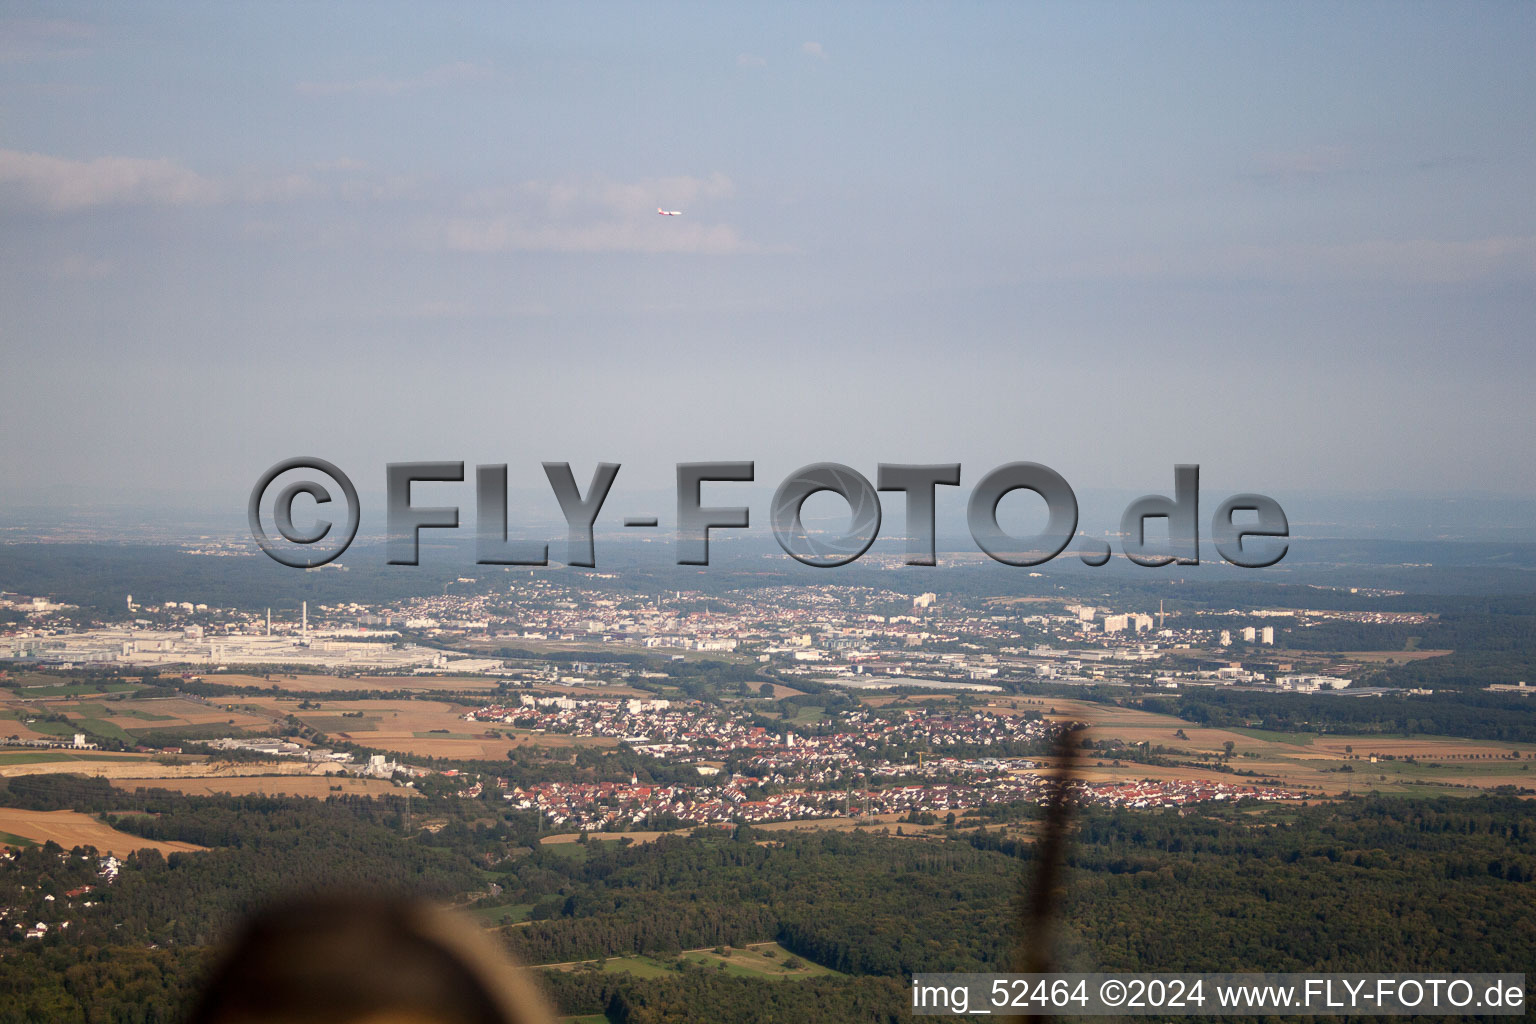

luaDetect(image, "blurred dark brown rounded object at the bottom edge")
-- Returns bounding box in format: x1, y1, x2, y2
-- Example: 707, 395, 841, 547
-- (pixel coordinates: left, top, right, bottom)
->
190, 897, 554, 1024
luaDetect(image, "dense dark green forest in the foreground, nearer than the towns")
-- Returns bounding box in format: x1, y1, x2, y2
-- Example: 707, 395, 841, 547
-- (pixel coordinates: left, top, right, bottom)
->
0, 777, 1536, 1024
